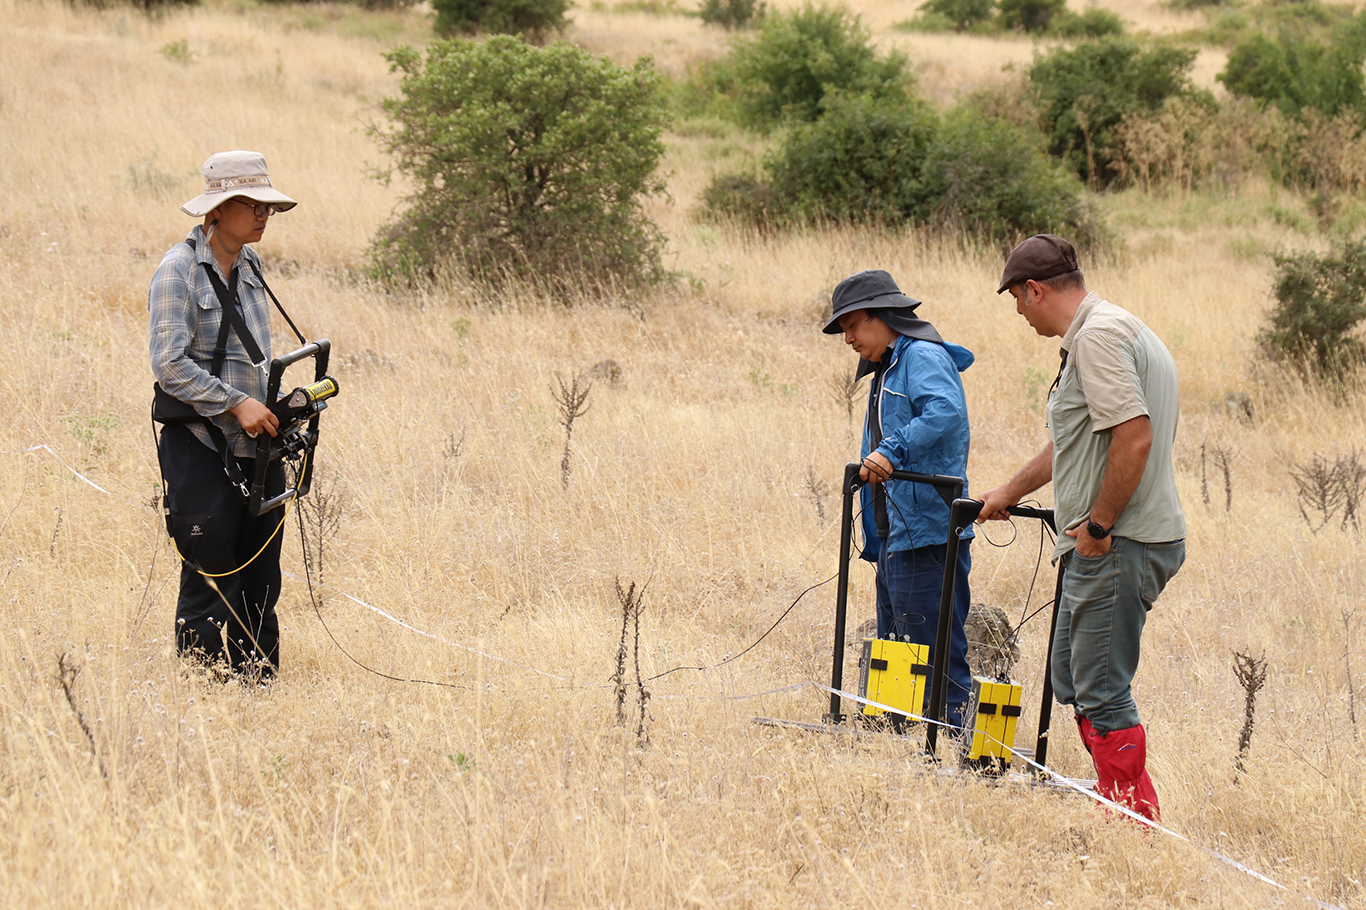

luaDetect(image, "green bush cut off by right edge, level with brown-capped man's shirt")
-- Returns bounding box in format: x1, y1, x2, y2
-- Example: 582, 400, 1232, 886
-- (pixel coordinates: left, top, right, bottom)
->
1261, 240, 1366, 378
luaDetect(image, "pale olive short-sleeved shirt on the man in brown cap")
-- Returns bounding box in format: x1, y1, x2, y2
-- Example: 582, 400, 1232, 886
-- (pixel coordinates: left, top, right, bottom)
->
1048, 292, 1186, 560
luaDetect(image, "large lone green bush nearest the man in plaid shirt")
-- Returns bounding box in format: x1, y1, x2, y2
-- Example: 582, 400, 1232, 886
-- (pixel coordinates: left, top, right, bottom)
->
370, 36, 667, 297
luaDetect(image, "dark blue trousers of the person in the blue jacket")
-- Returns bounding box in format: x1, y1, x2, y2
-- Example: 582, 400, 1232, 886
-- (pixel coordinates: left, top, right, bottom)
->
877, 540, 973, 724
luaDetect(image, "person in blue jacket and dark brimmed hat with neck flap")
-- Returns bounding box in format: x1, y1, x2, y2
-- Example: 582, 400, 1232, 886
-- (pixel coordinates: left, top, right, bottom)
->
825, 269, 973, 724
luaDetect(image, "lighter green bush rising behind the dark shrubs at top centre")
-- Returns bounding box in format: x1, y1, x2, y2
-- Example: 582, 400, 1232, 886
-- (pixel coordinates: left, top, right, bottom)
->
717, 4, 912, 131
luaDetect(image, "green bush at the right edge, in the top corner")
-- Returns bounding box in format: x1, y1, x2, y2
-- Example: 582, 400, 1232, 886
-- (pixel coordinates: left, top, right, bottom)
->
1216, 27, 1366, 116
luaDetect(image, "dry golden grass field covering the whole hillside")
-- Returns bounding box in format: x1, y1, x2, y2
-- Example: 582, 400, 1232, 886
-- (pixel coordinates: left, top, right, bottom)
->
0, 0, 1366, 909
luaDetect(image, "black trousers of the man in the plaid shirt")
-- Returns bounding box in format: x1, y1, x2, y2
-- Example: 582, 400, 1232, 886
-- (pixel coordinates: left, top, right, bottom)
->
158, 425, 287, 676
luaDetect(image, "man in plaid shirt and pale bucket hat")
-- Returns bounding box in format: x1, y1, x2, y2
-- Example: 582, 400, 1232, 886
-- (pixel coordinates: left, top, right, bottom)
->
148, 152, 296, 679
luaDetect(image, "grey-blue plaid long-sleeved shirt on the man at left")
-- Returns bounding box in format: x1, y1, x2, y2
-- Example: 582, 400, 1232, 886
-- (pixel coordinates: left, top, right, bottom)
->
148, 225, 270, 458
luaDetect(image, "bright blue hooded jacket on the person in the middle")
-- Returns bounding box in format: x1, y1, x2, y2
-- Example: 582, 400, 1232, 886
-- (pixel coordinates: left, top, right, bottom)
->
859, 335, 974, 560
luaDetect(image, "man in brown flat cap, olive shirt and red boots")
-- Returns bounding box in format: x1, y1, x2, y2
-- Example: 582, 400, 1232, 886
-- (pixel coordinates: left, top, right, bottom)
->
978, 234, 1186, 821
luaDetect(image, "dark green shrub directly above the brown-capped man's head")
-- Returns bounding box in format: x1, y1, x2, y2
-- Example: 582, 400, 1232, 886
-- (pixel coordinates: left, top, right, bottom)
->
915, 108, 1101, 246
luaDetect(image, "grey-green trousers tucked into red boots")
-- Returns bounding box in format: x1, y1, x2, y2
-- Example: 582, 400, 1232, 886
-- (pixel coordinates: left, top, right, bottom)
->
1052, 537, 1186, 732
